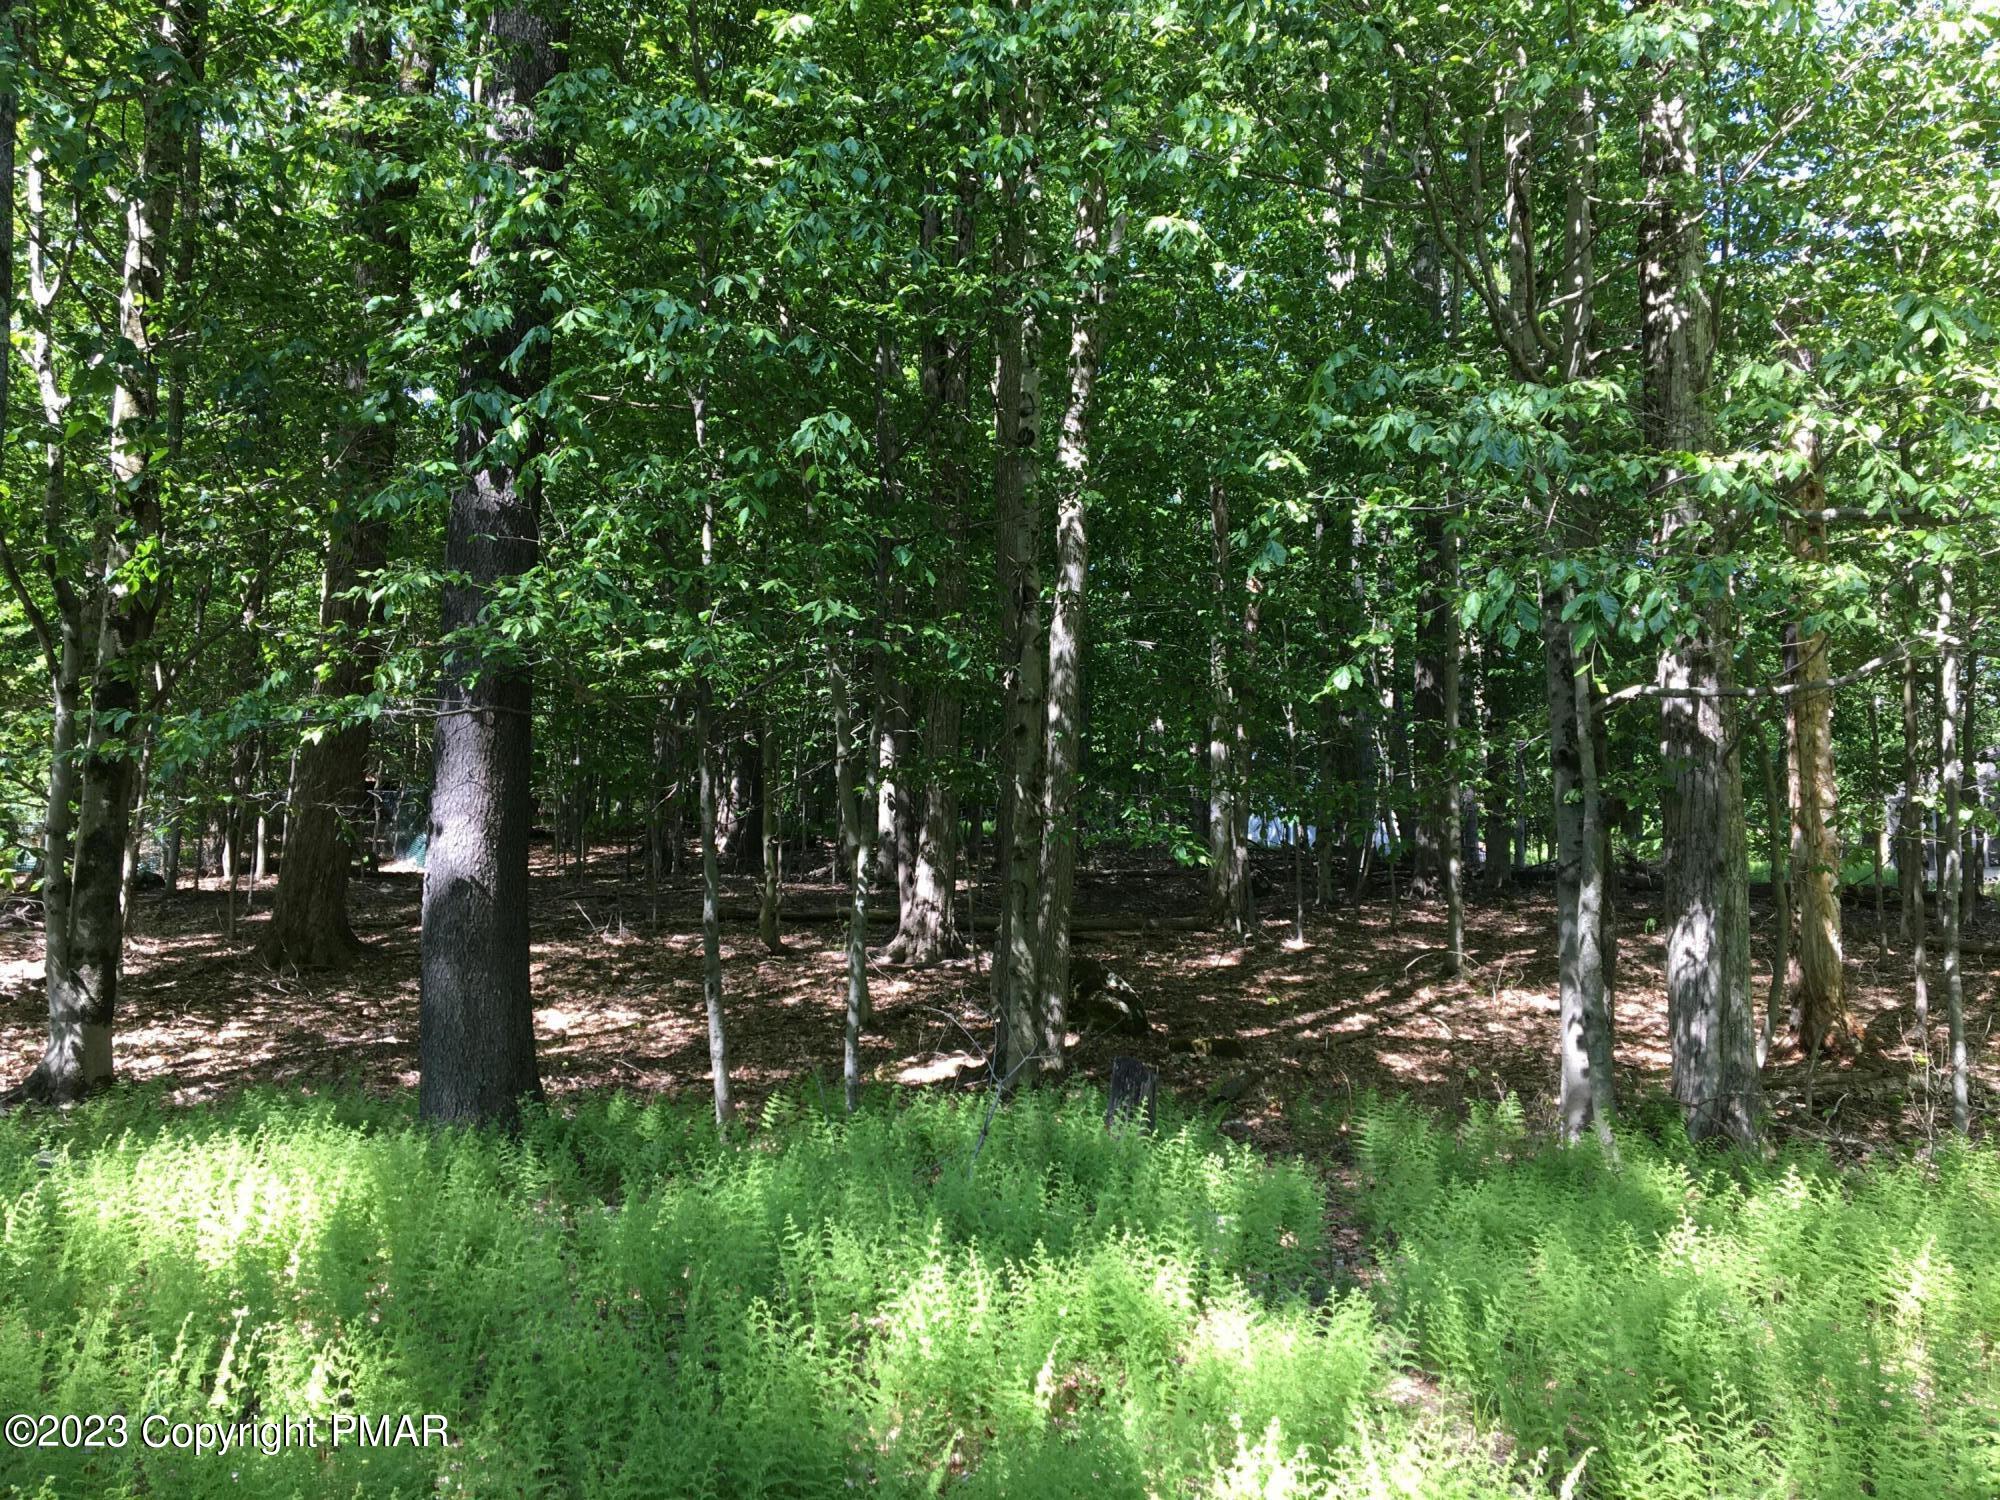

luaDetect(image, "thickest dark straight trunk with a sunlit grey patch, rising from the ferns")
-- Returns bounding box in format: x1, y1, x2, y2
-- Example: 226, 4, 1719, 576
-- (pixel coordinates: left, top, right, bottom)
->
418, 6, 566, 1124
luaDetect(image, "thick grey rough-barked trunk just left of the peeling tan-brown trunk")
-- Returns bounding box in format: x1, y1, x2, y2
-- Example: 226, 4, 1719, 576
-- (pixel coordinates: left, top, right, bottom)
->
1640, 29, 1760, 1144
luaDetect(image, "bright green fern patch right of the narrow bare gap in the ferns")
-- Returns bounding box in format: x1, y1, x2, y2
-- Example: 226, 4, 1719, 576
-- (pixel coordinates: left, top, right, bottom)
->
1356, 1104, 2000, 1500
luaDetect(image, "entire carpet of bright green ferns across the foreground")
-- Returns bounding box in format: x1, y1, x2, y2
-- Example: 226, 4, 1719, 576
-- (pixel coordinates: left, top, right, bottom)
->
0, 1092, 2000, 1500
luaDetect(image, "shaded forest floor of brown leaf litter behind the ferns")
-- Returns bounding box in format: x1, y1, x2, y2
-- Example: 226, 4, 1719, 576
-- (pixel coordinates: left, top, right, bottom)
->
0, 850, 2000, 1152
